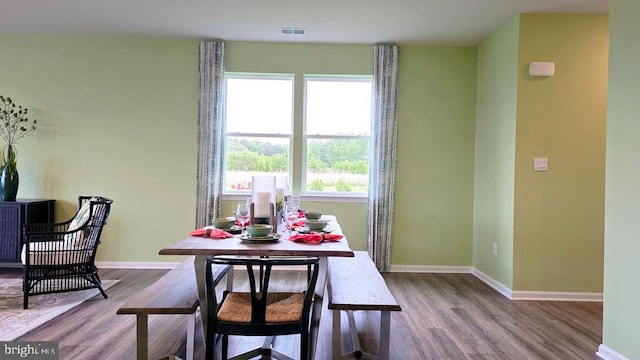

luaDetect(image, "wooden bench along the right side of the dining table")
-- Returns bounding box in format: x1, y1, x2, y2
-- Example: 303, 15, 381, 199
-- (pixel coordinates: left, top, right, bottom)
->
327, 251, 402, 360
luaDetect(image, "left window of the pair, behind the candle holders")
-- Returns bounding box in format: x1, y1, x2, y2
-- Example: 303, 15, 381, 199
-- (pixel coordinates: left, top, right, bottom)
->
224, 74, 293, 193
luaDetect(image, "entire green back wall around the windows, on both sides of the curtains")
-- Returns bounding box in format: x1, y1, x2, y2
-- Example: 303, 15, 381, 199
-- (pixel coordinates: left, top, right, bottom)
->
0, 35, 475, 265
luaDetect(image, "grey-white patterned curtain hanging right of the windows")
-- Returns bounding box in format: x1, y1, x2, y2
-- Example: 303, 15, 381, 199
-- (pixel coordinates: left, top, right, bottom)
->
368, 45, 399, 271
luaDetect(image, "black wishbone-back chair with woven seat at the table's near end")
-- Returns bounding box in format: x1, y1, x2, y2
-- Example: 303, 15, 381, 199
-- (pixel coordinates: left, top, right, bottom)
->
205, 256, 319, 360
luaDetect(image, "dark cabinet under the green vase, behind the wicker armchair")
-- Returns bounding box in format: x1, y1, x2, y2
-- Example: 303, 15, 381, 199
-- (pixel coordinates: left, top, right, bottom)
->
0, 199, 55, 264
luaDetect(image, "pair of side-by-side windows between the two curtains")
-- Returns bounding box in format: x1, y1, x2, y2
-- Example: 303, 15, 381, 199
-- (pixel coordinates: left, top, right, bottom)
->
224, 73, 372, 196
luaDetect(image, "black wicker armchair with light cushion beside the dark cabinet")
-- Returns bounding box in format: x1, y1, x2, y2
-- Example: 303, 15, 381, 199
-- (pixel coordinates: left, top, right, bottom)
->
22, 196, 113, 309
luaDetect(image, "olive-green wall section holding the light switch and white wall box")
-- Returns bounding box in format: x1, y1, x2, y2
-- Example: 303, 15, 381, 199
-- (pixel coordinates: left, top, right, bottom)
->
513, 14, 609, 292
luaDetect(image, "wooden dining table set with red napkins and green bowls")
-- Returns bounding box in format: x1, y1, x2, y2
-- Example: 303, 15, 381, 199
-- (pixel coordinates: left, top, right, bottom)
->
159, 215, 354, 359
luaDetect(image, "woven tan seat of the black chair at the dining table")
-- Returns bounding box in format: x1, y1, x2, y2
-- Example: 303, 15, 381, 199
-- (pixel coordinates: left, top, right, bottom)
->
218, 292, 304, 323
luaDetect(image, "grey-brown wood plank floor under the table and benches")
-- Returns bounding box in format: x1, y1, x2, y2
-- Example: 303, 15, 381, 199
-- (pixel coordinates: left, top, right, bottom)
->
0, 269, 602, 360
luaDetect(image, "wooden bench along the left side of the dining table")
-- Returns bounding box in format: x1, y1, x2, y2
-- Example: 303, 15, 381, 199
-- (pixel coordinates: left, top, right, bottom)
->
117, 256, 231, 360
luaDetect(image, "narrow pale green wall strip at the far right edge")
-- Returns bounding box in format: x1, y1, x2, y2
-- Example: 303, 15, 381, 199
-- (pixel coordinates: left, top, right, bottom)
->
603, 0, 640, 359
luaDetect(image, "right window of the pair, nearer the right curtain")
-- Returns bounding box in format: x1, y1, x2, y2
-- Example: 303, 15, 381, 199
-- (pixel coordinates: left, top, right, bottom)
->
304, 76, 371, 194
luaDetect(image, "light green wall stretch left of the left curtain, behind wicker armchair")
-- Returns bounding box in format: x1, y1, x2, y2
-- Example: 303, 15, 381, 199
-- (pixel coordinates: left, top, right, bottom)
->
0, 35, 198, 261
